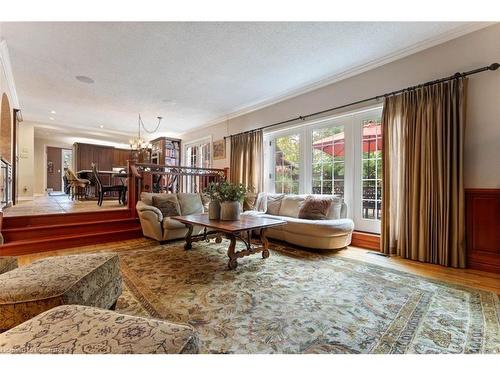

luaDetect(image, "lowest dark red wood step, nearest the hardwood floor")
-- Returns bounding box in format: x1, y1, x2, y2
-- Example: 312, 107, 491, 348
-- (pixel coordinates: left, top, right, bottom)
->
0, 225, 142, 256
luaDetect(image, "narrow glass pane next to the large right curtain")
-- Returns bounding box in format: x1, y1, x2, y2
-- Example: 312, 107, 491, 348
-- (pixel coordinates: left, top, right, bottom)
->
361, 118, 382, 220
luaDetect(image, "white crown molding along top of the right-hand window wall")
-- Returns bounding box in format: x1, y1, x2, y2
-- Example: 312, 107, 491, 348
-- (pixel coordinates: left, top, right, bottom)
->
193, 22, 497, 134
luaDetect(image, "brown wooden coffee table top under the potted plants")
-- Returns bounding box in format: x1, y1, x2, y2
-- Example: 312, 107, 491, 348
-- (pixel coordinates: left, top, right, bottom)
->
171, 214, 286, 232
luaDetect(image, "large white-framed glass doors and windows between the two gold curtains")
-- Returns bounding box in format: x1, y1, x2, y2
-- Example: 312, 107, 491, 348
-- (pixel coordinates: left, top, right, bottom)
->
264, 107, 382, 233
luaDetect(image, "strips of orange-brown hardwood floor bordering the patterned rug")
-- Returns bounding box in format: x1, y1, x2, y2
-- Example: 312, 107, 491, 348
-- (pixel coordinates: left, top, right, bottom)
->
18, 238, 500, 295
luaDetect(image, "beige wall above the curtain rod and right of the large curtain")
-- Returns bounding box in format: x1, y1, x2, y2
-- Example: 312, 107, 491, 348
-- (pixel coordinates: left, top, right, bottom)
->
181, 24, 500, 188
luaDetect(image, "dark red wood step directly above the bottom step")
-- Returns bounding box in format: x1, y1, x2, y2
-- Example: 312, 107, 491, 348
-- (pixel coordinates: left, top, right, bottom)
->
2, 218, 140, 244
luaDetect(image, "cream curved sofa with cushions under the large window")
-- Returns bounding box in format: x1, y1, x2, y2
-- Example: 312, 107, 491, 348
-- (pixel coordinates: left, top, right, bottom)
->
242, 193, 354, 249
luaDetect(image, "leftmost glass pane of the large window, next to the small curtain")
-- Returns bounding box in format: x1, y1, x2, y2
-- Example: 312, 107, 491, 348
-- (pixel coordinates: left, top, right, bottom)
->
274, 134, 300, 194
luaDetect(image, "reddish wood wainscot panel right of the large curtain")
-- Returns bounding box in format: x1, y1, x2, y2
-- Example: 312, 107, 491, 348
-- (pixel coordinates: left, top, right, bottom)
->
465, 189, 500, 273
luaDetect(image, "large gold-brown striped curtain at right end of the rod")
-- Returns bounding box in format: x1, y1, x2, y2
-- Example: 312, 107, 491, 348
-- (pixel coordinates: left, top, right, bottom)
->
381, 78, 467, 268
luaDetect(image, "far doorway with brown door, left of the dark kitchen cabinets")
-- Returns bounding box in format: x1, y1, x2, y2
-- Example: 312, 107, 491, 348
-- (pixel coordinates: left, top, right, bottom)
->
47, 146, 73, 194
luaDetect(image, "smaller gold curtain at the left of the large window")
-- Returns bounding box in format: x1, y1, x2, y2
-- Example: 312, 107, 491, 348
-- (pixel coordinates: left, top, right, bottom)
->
229, 130, 264, 193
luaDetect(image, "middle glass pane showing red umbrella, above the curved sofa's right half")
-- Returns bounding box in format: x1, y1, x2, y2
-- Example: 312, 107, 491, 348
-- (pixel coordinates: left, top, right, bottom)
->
312, 125, 345, 197
